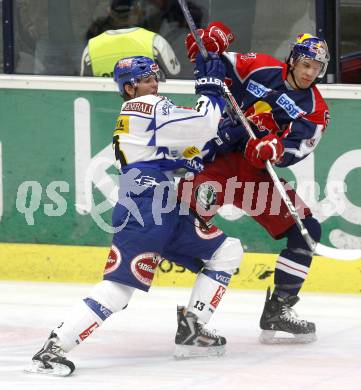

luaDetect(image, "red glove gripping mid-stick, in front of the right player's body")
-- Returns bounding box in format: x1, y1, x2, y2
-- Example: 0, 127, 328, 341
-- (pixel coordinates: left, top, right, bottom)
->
244, 134, 284, 169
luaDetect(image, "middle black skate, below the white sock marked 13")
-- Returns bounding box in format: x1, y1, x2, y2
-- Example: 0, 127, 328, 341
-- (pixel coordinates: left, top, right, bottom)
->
174, 306, 226, 359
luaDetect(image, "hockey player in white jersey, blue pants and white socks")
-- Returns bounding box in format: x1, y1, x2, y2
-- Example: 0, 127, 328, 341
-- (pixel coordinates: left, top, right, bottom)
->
27, 55, 242, 376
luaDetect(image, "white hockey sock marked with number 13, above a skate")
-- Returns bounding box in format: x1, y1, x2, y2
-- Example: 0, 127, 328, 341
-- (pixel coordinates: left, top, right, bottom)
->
187, 273, 227, 324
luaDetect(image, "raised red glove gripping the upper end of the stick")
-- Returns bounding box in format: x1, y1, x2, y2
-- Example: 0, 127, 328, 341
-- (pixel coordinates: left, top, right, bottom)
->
185, 22, 234, 62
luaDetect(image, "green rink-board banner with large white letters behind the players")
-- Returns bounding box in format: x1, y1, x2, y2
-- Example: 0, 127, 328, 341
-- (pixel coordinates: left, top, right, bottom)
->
0, 81, 361, 253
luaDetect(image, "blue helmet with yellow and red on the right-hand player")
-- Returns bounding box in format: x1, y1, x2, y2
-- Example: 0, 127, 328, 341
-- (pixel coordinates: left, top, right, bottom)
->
288, 33, 330, 79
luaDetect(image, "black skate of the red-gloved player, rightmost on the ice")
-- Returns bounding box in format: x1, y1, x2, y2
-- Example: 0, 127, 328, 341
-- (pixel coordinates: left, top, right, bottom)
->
259, 288, 316, 344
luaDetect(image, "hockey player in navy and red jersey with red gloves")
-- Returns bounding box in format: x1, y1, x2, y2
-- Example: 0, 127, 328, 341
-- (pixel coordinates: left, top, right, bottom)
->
179, 22, 329, 343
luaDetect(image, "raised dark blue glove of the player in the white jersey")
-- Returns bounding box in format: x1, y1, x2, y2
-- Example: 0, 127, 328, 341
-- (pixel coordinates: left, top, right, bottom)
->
194, 53, 226, 96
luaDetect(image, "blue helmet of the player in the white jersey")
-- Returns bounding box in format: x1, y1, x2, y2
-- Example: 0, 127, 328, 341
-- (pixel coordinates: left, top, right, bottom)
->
113, 56, 161, 96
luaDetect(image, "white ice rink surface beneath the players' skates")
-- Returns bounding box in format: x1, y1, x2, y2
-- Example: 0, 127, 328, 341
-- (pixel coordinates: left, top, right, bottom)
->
0, 282, 361, 390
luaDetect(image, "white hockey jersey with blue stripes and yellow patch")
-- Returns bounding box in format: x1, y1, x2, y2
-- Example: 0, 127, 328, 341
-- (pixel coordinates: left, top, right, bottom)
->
113, 95, 224, 170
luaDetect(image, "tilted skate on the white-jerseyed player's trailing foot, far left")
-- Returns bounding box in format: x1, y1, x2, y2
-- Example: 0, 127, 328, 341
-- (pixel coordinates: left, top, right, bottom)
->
25, 332, 75, 376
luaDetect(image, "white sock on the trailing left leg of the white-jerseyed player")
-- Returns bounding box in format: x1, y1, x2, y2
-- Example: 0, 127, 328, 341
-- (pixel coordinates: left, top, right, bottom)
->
54, 280, 134, 352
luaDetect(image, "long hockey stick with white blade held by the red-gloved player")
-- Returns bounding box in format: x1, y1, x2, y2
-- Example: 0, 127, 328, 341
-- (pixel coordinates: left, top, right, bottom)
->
178, 0, 361, 260
